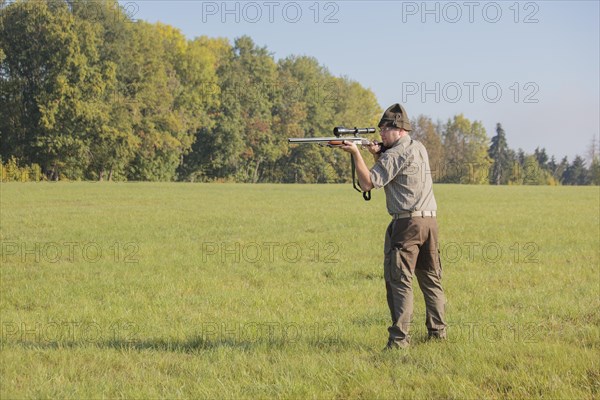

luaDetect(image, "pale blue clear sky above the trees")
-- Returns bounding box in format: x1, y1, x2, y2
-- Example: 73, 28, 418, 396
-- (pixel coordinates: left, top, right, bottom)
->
120, 0, 600, 161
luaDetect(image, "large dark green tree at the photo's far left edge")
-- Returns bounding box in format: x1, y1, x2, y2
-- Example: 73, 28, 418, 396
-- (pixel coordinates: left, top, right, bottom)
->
0, 1, 111, 179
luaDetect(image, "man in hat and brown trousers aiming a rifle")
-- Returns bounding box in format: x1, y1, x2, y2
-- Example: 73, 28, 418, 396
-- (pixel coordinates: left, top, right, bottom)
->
342, 104, 446, 349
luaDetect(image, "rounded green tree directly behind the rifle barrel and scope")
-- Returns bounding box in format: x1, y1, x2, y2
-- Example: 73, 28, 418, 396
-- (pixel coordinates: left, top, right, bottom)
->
275, 56, 364, 182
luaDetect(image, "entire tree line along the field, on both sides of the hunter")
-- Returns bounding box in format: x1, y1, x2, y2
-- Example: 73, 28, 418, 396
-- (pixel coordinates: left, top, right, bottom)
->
0, 0, 600, 184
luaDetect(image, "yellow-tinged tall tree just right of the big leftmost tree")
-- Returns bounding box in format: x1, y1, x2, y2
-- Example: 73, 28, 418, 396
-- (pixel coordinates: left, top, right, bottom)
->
123, 22, 209, 181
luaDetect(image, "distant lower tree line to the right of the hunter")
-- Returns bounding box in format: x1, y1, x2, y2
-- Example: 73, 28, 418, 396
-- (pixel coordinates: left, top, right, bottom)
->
412, 114, 600, 185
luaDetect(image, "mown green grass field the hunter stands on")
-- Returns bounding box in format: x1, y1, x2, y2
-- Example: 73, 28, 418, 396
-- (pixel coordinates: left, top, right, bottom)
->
0, 183, 600, 399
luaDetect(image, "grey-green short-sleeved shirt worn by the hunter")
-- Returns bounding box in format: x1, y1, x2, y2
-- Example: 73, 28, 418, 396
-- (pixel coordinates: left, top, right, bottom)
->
370, 135, 437, 214
